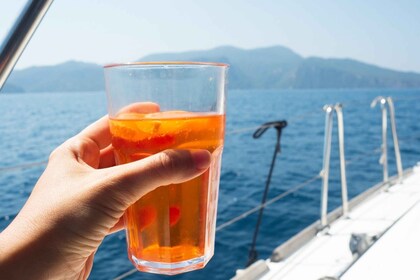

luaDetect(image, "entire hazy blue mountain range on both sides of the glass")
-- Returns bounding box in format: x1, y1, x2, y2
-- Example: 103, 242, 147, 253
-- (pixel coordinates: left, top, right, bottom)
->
2, 46, 420, 92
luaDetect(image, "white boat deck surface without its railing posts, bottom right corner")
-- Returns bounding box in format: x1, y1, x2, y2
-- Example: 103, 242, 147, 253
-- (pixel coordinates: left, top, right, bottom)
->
234, 167, 420, 280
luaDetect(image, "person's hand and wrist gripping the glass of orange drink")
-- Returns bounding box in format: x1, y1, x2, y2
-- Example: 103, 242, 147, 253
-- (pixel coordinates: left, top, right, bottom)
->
0, 117, 210, 279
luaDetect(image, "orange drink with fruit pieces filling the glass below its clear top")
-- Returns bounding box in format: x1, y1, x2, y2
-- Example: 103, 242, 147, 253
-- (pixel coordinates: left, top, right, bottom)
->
110, 111, 225, 274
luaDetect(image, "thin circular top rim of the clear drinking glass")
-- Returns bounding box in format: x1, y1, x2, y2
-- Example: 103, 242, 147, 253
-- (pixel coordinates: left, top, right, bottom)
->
103, 61, 230, 69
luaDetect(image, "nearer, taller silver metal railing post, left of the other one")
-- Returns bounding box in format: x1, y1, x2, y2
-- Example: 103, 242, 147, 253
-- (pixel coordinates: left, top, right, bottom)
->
320, 103, 348, 230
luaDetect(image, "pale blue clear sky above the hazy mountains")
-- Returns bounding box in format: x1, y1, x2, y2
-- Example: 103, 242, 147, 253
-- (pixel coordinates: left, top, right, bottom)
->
0, 0, 420, 72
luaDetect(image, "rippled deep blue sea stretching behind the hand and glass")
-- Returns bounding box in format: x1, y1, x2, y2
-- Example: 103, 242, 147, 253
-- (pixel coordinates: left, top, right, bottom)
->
0, 90, 420, 279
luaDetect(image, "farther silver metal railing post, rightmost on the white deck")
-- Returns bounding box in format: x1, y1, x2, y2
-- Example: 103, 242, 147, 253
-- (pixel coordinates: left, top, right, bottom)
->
370, 96, 403, 183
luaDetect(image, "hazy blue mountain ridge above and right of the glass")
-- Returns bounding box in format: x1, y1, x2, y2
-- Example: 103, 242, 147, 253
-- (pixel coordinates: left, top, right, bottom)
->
140, 46, 420, 89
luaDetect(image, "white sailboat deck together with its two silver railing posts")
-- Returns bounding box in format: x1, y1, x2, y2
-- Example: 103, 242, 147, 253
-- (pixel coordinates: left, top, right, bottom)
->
232, 97, 420, 280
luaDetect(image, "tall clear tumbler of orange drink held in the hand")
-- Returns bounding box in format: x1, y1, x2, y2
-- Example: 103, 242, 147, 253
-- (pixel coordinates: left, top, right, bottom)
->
104, 62, 228, 275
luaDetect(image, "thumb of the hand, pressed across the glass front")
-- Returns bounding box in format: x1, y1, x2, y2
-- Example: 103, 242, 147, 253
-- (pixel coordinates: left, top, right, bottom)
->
97, 149, 211, 208
